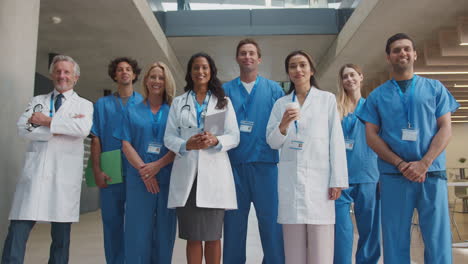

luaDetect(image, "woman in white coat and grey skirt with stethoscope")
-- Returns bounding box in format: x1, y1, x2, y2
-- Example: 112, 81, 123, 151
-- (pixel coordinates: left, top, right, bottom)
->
164, 53, 239, 264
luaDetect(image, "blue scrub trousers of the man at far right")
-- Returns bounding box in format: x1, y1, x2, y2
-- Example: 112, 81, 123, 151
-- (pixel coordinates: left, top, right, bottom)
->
380, 174, 452, 264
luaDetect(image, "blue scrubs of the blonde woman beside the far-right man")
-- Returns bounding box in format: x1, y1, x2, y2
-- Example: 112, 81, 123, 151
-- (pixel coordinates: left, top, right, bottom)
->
333, 98, 380, 264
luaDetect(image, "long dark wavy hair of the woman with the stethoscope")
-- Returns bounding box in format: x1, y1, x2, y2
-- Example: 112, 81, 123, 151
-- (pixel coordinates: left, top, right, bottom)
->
184, 52, 227, 109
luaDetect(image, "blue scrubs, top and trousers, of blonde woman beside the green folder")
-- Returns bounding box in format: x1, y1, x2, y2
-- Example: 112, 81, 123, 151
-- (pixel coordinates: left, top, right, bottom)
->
114, 102, 176, 264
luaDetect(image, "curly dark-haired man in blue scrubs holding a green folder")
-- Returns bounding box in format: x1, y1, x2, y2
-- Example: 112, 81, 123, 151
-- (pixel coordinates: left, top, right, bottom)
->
91, 57, 143, 264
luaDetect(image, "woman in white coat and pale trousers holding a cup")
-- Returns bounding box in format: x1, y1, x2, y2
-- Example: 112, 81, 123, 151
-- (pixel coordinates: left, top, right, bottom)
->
267, 51, 348, 264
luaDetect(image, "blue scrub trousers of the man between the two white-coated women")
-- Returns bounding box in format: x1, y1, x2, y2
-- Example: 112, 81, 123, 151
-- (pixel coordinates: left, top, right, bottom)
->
223, 163, 284, 264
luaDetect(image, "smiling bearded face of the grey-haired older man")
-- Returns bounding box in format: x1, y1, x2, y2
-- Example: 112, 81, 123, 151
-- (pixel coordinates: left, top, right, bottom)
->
51, 61, 79, 93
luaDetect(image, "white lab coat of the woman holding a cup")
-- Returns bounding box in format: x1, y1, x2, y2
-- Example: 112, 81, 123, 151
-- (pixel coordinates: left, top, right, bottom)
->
267, 87, 348, 225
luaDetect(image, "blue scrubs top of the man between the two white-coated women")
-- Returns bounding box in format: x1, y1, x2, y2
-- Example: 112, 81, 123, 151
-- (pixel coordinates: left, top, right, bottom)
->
223, 76, 284, 164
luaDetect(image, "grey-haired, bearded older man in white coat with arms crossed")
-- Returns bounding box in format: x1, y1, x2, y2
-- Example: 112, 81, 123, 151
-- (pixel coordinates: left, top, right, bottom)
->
2, 55, 93, 264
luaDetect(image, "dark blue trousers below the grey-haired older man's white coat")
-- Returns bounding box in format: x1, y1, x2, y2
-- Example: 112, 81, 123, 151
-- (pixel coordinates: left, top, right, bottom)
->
2, 220, 71, 264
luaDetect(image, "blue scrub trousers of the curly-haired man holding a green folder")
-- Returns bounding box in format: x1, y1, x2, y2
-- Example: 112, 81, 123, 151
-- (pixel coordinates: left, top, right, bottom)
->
100, 183, 125, 264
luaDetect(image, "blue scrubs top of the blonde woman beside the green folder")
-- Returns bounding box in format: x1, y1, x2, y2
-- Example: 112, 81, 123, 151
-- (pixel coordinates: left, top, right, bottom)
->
114, 102, 172, 184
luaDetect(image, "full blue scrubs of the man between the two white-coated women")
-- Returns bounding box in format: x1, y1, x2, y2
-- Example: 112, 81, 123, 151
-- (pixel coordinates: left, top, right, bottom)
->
223, 76, 284, 264
